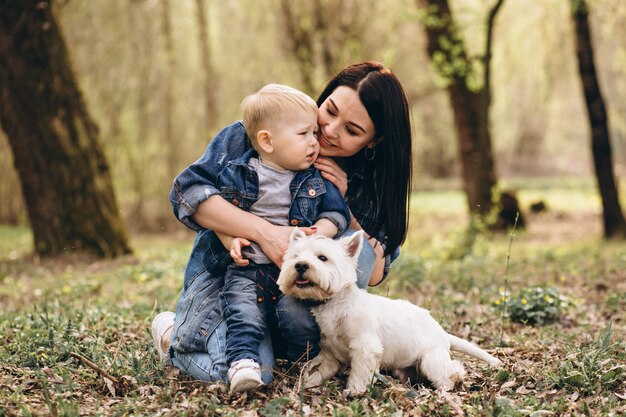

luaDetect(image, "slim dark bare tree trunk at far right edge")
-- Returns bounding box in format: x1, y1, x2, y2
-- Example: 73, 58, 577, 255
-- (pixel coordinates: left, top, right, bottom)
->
570, 0, 626, 238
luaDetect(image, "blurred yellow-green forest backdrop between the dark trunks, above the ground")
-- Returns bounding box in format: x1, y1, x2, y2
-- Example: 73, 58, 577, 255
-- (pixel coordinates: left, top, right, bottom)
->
0, 0, 626, 232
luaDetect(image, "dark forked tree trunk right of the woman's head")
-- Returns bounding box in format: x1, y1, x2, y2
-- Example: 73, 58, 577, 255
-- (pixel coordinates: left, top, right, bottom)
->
418, 0, 503, 215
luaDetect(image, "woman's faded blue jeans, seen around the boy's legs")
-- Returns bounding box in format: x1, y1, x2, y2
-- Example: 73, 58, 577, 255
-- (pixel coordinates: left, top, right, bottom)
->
170, 229, 376, 383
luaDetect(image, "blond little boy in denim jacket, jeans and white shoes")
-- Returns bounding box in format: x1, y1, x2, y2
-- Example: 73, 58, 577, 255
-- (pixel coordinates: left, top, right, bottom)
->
210, 84, 350, 392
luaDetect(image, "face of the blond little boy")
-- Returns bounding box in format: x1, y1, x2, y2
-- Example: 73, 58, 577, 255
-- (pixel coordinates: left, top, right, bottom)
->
263, 110, 319, 171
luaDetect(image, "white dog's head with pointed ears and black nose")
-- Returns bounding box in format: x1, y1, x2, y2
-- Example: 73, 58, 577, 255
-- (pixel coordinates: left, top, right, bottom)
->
277, 228, 363, 300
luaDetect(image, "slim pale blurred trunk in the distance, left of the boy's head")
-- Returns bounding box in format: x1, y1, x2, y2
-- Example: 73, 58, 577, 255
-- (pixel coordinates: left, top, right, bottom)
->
196, 0, 217, 134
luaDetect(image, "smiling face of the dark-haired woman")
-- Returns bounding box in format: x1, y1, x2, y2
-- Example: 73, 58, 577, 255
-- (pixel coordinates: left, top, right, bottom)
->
317, 86, 375, 157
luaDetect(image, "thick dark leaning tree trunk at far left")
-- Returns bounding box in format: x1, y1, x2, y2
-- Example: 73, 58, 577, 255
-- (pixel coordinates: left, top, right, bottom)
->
0, 0, 131, 256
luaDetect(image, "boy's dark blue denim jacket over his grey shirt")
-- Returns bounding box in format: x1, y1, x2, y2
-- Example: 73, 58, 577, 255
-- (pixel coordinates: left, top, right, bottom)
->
190, 148, 350, 274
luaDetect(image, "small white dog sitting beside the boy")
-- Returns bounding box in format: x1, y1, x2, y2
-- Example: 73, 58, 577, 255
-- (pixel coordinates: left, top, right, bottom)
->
278, 229, 501, 394
